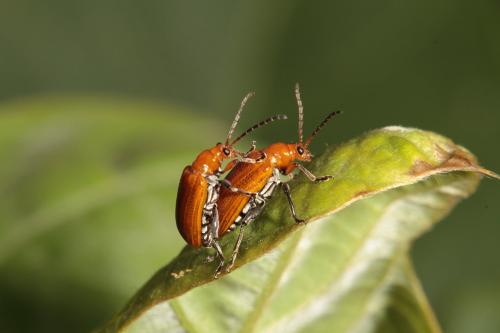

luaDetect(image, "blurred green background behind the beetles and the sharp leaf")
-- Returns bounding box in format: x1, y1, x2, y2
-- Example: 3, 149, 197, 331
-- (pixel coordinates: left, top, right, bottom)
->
0, 0, 500, 332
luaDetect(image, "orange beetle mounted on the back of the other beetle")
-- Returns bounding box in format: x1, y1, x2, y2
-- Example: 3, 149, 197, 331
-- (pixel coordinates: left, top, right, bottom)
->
175, 93, 286, 271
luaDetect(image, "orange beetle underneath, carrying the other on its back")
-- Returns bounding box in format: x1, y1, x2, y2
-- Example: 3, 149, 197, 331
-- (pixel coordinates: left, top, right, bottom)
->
217, 84, 340, 272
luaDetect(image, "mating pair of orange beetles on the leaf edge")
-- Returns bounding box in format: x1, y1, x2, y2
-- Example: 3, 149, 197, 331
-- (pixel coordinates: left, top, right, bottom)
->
176, 84, 339, 277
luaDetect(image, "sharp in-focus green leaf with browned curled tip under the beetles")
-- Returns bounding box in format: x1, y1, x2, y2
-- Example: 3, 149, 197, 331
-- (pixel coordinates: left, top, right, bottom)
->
101, 127, 498, 332
